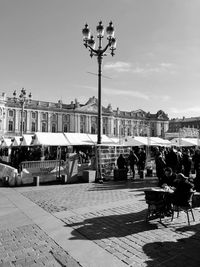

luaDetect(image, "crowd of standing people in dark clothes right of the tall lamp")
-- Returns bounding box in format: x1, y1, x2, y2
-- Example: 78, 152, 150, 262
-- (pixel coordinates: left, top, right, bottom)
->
117, 147, 200, 191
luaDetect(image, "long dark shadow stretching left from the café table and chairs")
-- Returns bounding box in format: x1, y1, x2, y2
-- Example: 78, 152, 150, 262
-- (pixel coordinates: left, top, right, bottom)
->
65, 210, 158, 240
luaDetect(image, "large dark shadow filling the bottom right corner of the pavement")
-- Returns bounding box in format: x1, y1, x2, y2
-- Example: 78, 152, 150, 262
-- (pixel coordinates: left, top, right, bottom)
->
143, 224, 200, 267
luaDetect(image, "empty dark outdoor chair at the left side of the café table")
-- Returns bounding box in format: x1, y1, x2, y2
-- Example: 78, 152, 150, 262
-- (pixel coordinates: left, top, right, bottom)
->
144, 191, 166, 222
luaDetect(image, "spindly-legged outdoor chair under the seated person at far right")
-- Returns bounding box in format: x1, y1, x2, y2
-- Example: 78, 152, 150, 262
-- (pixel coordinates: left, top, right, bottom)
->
171, 192, 195, 225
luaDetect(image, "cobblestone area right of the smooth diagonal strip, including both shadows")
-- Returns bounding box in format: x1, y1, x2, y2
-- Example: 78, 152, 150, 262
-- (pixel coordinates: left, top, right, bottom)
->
19, 182, 200, 267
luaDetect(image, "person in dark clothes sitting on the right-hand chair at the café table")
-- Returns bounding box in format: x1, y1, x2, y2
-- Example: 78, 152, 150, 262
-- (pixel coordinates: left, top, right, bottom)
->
172, 173, 194, 207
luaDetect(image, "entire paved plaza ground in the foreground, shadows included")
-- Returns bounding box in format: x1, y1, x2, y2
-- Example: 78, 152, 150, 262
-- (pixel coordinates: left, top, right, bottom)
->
0, 178, 200, 267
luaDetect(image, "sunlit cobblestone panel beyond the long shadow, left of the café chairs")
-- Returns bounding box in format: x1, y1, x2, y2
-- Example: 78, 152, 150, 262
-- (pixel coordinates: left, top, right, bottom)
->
23, 182, 156, 213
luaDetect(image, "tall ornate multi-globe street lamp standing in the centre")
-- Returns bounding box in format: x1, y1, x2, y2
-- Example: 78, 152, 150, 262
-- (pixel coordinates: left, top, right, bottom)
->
82, 21, 116, 179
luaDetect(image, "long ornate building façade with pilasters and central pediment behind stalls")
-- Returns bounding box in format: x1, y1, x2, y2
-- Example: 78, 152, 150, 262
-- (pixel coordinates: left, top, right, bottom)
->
0, 93, 169, 137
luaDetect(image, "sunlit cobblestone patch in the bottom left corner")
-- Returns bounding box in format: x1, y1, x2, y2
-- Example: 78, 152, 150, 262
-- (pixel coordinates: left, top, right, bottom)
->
0, 224, 81, 267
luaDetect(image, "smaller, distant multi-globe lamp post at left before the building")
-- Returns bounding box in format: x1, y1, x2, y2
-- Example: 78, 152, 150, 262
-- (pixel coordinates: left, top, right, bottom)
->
13, 88, 32, 136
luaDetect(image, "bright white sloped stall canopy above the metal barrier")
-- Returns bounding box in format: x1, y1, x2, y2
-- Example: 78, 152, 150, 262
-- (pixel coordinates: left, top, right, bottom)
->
32, 132, 71, 146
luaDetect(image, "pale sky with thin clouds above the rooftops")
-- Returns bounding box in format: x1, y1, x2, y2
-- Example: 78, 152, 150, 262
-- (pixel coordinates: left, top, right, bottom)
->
0, 0, 200, 118
